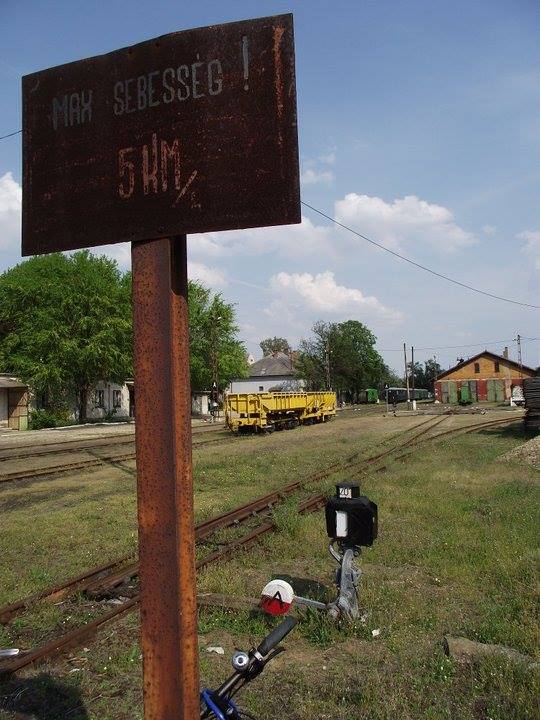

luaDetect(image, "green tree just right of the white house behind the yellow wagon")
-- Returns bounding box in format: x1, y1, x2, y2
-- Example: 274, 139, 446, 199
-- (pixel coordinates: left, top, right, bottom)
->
295, 320, 390, 399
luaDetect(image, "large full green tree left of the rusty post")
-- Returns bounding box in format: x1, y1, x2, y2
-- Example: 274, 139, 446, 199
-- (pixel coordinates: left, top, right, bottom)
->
0, 250, 133, 422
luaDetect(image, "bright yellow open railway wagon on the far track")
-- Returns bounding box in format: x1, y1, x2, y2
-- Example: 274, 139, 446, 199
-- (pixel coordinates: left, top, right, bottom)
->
223, 391, 336, 433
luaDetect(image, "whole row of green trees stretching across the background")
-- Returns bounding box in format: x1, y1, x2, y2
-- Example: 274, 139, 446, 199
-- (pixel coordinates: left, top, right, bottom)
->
0, 250, 434, 422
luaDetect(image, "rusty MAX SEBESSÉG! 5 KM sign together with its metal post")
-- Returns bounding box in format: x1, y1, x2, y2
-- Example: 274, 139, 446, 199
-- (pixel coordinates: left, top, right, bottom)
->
22, 15, 300, 720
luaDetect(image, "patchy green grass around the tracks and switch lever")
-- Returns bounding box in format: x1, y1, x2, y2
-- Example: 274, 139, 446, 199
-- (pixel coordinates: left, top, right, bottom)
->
0, 418, 540, 720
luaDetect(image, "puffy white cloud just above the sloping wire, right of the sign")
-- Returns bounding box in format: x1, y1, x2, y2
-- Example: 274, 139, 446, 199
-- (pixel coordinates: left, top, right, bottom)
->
335, 193, 476, 253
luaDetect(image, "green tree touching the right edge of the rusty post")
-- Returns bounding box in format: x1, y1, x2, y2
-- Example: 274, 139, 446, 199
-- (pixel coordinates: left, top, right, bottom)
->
188, 280, 248, 390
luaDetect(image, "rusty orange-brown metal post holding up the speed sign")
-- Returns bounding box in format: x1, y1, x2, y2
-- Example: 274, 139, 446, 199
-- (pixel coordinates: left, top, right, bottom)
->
132, 236, 199, 720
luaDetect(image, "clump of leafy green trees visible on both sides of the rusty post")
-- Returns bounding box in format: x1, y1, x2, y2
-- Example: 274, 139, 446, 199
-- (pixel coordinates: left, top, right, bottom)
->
0, 250, 247, 422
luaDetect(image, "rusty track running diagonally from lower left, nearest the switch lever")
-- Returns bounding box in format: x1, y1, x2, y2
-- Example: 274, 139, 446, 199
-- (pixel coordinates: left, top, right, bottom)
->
0, 416, 516, 675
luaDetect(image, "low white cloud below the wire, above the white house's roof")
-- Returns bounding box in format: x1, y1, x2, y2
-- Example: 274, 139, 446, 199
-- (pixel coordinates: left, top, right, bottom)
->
269, 270, 403, 321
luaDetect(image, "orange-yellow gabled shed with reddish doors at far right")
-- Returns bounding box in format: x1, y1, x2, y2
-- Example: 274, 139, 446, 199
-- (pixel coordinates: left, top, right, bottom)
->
435, 349, 537, 404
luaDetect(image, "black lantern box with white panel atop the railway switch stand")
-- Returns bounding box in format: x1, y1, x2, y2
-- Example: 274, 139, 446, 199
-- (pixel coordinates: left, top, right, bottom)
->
325, 483, 377, 547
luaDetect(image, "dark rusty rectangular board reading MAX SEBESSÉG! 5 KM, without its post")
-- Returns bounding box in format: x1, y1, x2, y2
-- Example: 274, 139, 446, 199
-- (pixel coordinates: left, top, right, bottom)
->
22, 15, 300, 255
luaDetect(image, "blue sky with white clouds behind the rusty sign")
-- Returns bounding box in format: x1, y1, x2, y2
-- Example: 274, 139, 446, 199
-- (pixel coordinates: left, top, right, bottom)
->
0, 0, 540, 369
